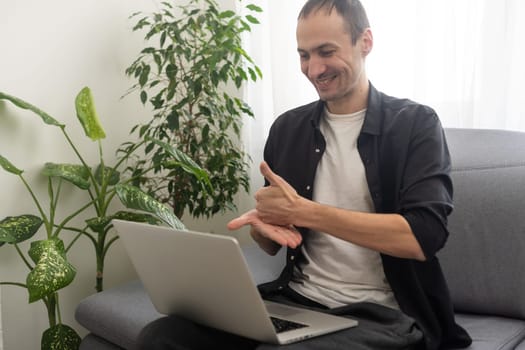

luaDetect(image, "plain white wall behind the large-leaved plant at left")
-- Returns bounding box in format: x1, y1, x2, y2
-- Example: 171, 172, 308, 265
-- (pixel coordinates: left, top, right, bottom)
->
0, 0, 251, 350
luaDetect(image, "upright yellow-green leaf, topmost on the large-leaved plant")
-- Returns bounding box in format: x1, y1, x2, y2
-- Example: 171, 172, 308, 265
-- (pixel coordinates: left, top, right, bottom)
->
75, 87, 106, 141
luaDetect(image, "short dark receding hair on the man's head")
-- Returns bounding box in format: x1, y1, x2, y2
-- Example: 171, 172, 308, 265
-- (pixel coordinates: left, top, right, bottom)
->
299, 0, 370, 45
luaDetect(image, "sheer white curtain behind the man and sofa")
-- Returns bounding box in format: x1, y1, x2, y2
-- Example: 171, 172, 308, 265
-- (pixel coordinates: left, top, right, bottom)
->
244, 0, 525, 182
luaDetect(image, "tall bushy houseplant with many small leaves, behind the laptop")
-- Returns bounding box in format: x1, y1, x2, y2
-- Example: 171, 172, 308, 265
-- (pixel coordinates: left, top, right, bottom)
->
122, 0, 262, 218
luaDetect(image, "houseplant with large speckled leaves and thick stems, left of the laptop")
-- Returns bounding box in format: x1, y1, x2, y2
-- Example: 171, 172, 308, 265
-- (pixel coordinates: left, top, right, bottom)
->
0, 88, 209, 349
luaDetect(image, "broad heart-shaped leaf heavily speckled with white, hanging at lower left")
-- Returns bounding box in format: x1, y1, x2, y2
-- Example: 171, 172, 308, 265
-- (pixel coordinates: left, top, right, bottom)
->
26, 238, 76, 303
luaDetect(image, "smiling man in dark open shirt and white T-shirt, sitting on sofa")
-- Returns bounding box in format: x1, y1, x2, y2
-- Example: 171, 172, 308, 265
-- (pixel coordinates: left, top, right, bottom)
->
138, 0, 471, 349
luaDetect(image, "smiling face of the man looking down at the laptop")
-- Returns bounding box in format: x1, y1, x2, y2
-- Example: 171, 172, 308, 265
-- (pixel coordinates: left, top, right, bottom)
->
297, 9, 372, 114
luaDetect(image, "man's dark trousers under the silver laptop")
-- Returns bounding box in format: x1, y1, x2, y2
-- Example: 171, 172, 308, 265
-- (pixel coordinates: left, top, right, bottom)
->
138, 289, 423, 350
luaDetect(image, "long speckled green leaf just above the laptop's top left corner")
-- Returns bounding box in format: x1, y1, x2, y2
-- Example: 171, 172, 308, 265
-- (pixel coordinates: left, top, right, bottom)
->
115, 184, 186, 230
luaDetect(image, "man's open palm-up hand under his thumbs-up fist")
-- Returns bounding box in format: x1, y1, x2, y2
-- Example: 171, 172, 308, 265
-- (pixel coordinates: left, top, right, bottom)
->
227, 209, 302, 255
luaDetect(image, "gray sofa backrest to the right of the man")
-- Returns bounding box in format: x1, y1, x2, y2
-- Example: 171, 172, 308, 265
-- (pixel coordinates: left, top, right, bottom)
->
439, 129, 525, 318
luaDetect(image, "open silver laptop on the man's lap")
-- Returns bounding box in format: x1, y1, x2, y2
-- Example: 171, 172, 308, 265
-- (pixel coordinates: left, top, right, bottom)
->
113, 220, 357, 344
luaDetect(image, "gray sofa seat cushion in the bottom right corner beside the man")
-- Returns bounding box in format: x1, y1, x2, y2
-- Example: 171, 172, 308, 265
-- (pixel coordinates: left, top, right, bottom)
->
456, 314, 525, 350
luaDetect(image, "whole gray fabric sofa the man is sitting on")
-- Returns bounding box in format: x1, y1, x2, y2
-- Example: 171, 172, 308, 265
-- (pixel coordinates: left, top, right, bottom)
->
76, 129, 525, 350
